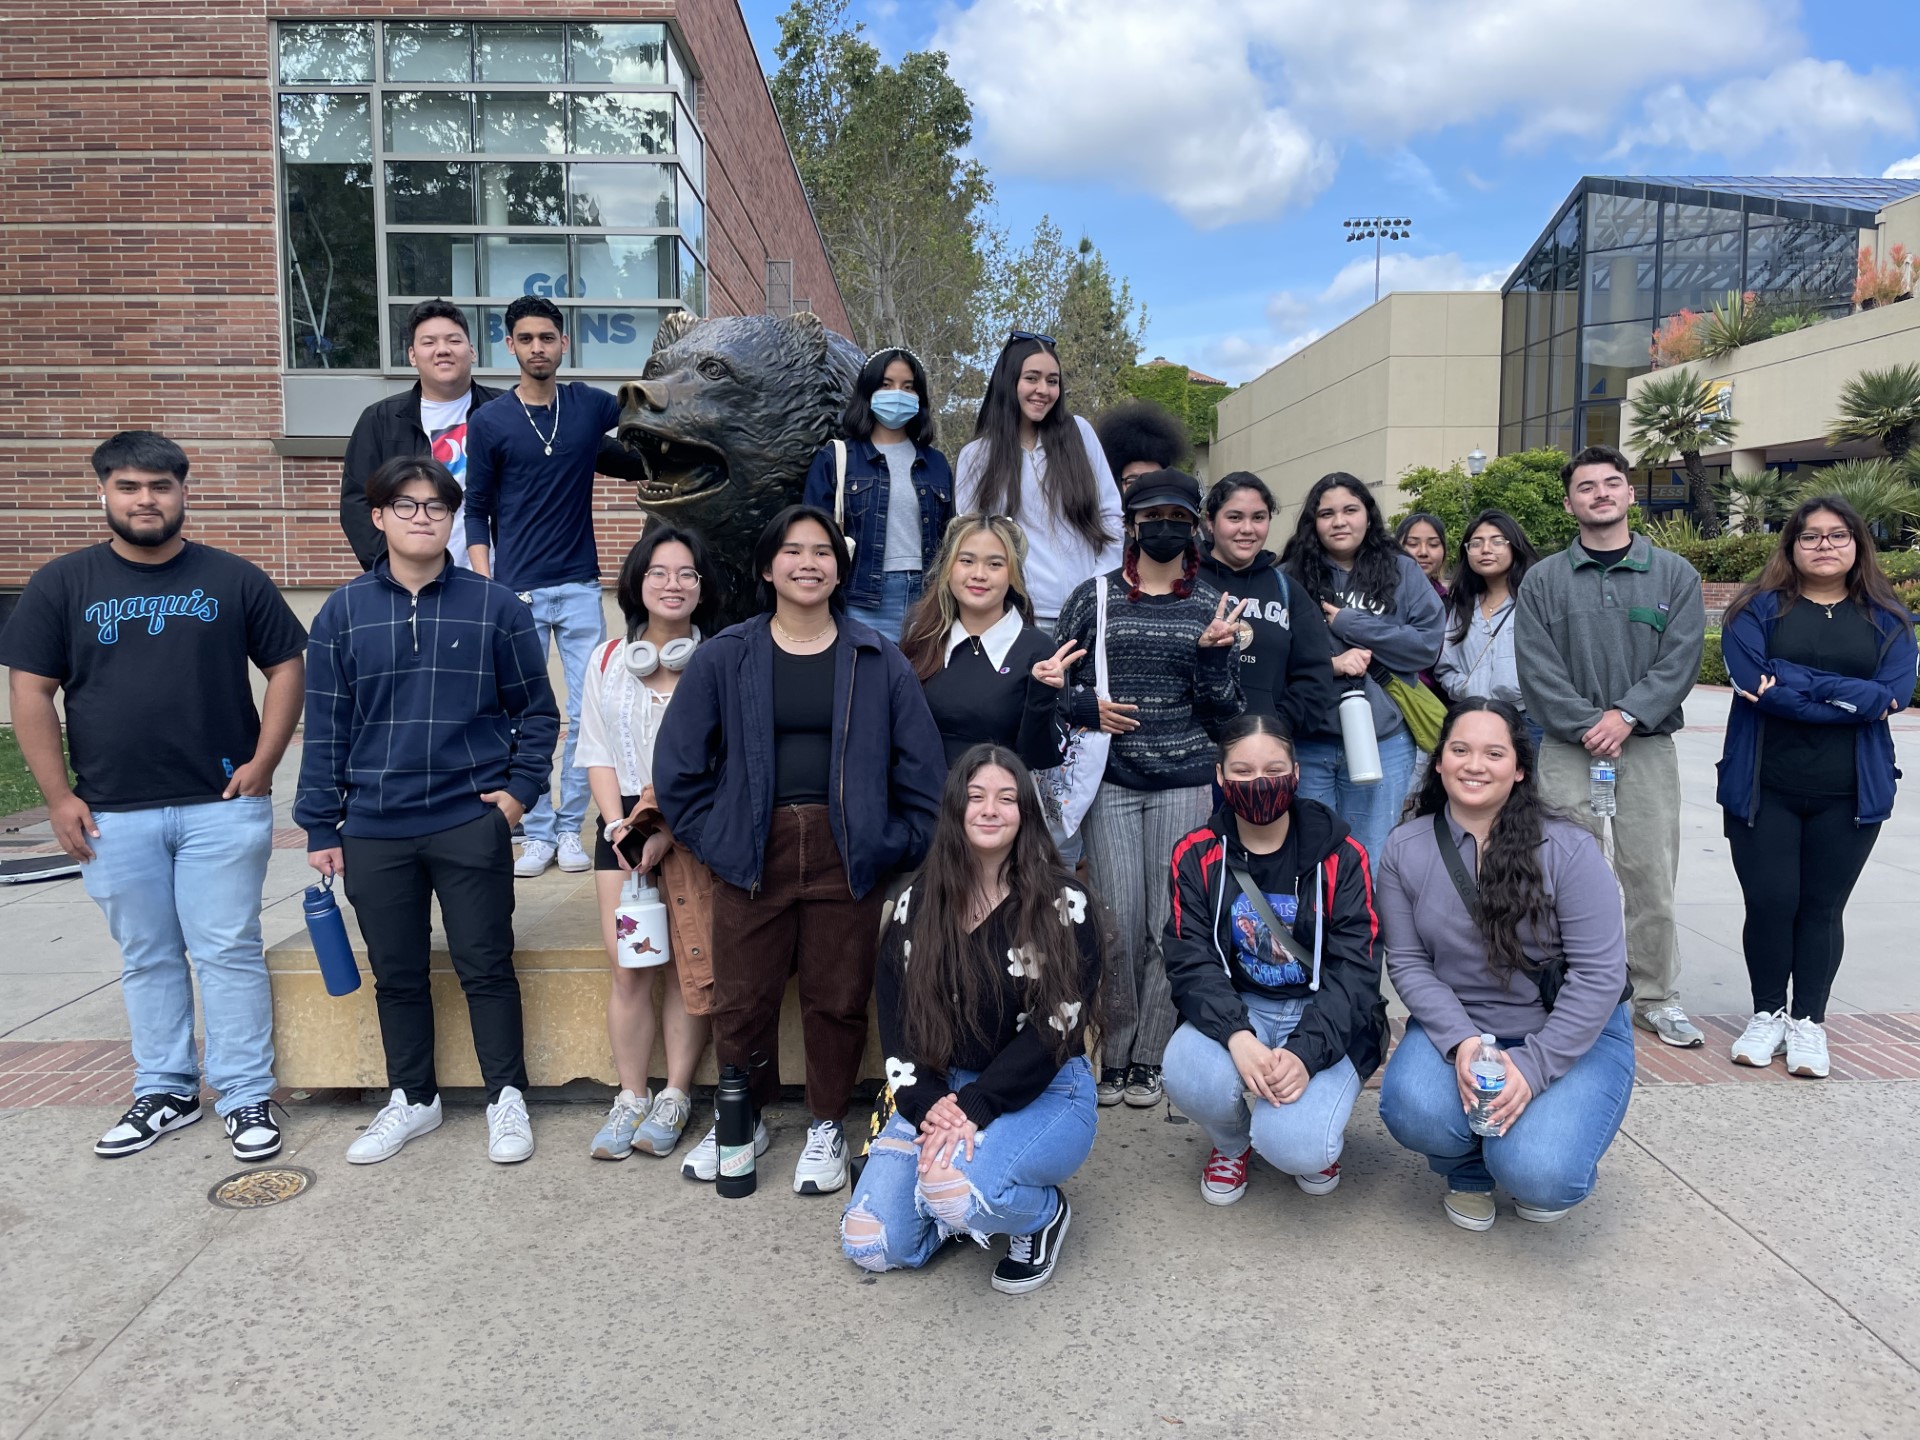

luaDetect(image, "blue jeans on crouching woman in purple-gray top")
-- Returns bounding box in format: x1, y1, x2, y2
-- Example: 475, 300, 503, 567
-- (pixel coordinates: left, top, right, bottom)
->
1380, 1004, 1634, 1210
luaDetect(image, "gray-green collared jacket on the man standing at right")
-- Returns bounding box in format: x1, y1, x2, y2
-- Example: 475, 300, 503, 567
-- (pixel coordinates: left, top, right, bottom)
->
1513, 536, 1707, 745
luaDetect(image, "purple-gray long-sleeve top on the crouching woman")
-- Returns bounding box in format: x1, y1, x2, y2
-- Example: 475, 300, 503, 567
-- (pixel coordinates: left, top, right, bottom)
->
1379, 814, 1626, 1094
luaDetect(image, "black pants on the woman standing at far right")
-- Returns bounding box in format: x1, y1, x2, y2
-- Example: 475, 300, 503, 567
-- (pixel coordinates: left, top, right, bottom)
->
1726, 787, 1880, 1020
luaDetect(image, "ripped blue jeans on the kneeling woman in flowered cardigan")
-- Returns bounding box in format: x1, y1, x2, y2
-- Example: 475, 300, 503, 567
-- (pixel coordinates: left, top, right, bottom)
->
841, 1056, 1100, 1271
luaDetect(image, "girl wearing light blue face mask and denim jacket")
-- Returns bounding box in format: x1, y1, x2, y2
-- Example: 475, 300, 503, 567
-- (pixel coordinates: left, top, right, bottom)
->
804, 349, 954, 643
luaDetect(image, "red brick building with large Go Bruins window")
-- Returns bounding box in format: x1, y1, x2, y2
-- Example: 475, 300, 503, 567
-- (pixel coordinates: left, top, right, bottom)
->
0, 0, 849, 612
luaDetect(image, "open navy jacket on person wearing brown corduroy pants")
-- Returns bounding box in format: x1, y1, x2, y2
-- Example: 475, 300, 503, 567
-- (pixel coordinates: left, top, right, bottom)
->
653, 614, 947, 899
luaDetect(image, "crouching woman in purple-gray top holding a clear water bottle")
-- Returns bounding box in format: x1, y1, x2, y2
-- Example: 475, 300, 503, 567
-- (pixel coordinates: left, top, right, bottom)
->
1380, 697, 1634, 1231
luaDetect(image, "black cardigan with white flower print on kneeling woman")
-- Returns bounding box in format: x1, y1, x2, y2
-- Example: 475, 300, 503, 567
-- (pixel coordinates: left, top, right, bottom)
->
874, 876, 1100, 1129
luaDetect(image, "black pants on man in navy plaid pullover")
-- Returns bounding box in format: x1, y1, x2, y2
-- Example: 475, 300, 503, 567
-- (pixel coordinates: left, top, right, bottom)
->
340, 810, 526, 1104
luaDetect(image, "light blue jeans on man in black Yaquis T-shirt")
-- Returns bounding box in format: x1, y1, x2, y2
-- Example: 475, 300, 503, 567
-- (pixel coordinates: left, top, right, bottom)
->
81, 795, 273, 1116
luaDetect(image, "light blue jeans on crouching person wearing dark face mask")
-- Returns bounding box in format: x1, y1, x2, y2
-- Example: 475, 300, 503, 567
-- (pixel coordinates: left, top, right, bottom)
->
1162, 995, 1359, 1175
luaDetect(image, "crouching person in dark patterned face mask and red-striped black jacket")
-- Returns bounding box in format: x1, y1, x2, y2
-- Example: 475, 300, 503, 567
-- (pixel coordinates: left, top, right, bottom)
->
1160, 714, 1386, 1206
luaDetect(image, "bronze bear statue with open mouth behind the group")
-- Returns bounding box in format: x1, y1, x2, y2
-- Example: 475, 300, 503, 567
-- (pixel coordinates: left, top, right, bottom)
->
614, 311, 866, 624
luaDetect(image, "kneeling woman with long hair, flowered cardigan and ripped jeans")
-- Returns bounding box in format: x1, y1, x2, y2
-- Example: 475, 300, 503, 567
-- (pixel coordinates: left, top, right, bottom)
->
841, 745, 1100, 1294
